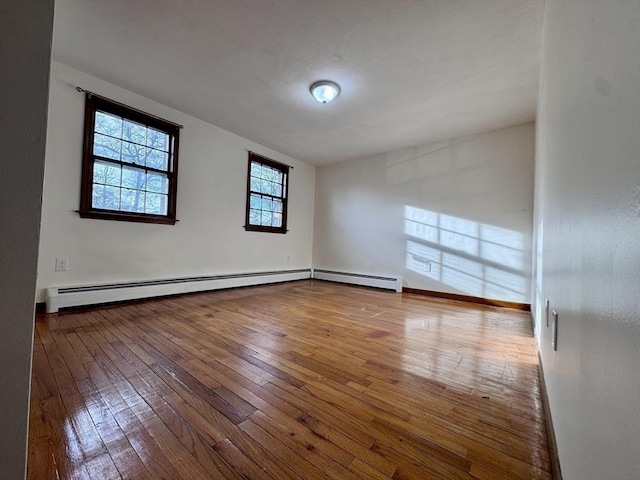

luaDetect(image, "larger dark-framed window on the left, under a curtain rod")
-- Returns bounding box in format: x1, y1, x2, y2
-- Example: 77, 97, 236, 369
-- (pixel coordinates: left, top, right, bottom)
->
79, 93, 180, 224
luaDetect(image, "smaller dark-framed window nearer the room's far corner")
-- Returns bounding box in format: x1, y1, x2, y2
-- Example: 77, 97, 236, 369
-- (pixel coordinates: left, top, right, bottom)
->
244, 152, 289, 233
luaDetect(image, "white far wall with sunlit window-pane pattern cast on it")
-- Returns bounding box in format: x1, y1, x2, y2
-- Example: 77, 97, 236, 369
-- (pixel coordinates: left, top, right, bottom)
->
313, 123, 534, 303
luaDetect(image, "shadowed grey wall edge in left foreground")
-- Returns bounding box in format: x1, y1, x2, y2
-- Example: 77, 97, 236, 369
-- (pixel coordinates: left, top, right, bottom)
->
0, 0, 53, 480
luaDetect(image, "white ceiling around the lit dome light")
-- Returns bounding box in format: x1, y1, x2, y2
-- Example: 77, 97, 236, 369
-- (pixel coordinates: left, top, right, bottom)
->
53, 0, 544, 165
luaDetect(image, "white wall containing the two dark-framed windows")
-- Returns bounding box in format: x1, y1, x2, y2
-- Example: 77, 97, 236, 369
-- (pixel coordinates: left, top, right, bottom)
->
38, 62, 315, 301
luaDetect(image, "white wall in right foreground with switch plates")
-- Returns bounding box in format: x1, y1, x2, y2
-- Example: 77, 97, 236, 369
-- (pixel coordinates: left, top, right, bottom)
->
534, 0, 640, 480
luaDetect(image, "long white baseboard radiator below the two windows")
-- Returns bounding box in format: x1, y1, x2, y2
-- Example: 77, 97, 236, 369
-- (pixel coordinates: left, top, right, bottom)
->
46, 268, 312, 313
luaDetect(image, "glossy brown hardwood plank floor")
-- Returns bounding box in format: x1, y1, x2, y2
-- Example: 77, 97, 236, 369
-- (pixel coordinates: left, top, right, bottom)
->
28, 281, 551, 480
